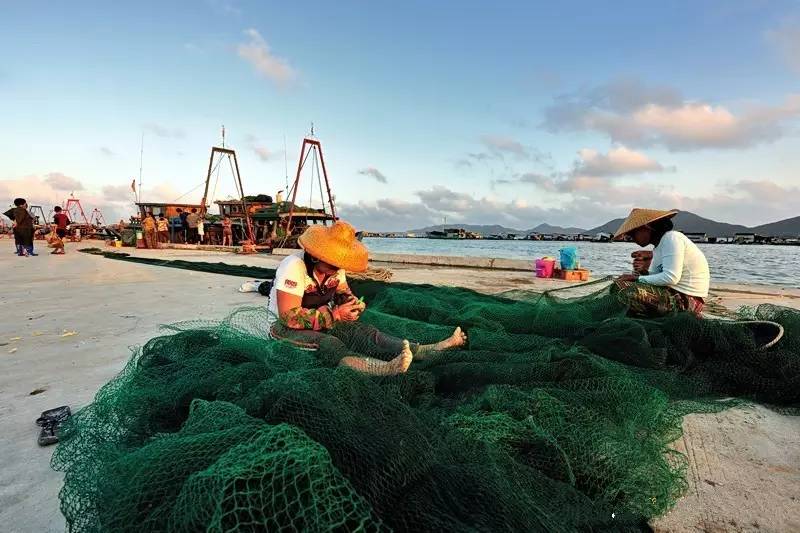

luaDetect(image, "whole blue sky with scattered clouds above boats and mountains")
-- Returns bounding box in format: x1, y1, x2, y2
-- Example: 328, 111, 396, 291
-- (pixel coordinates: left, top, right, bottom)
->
0, 0, 800, 231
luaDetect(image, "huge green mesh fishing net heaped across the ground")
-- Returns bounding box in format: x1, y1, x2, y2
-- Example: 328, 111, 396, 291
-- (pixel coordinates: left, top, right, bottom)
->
53, 251, 800, 532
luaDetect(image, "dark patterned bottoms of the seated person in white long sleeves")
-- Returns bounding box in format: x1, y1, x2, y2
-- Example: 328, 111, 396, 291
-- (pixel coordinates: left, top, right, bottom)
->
611, 280, 705, 318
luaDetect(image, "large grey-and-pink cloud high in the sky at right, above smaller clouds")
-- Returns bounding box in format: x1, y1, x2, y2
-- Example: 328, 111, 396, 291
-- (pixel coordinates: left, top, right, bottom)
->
544, 78, 800, 151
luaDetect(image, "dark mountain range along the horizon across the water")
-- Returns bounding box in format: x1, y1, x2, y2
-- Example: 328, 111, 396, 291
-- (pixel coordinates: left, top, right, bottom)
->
408, 211, 800, 237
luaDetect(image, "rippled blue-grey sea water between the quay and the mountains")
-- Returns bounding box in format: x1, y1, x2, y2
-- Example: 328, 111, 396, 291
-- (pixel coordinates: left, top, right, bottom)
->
364, 237, 800, 287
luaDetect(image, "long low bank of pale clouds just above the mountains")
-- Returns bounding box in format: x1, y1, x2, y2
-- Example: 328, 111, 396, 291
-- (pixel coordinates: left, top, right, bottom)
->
340, 173, 800, 231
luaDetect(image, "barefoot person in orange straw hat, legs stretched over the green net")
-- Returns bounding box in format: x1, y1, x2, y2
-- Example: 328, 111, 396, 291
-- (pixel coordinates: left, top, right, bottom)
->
267, 221, 467, 376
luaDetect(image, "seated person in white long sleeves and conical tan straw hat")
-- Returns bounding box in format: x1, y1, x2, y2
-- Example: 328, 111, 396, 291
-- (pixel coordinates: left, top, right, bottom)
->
614, 208, 710, 317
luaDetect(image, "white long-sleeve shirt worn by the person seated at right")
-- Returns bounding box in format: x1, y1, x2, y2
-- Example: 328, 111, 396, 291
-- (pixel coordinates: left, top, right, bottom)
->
639, 231, 711, 298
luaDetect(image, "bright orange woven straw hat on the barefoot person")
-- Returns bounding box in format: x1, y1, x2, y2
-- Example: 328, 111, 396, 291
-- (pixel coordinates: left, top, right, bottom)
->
298, 220, 369, 272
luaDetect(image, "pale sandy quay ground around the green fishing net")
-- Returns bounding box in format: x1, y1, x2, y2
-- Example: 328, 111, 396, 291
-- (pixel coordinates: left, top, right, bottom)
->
0, 242, 800, 531
